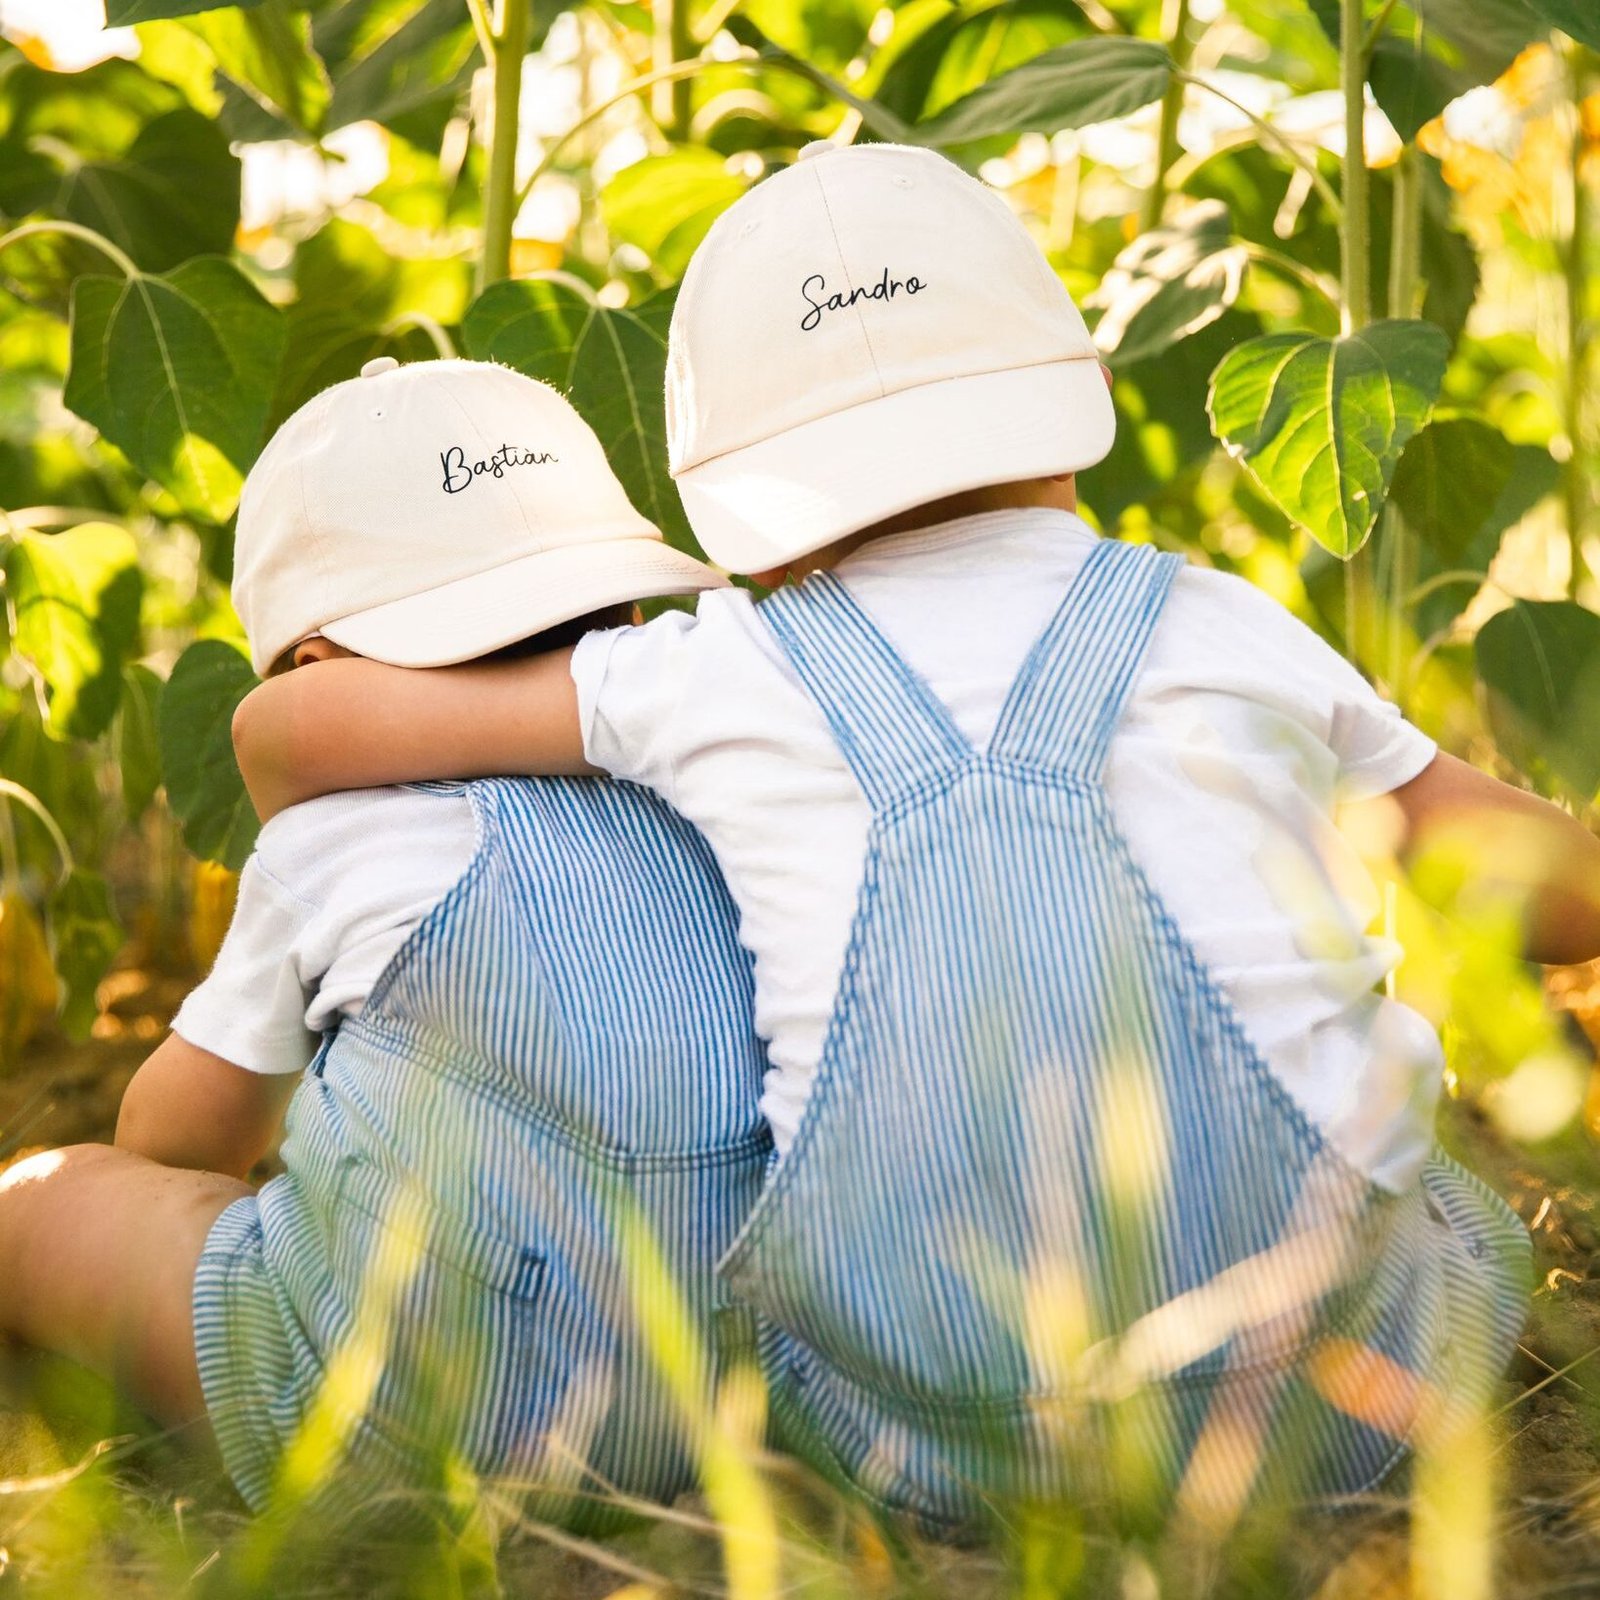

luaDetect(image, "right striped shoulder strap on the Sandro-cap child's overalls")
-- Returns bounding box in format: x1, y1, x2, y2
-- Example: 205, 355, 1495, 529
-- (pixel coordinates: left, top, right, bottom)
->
989, 539, 1184, 781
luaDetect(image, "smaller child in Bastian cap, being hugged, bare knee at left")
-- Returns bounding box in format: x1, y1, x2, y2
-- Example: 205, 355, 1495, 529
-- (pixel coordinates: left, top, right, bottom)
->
0, 360, 770, 1522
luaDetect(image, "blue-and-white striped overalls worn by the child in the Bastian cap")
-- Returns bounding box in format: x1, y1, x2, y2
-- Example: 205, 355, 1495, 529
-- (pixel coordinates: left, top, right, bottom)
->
195, 779, 771, 1526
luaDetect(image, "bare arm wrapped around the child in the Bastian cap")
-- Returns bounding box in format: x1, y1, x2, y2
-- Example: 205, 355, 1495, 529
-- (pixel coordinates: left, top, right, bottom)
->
234, 650, 595, 821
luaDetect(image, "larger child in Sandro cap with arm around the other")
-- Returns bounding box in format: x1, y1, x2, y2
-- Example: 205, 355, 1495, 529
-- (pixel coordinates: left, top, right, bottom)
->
235, 146, 1600, 1528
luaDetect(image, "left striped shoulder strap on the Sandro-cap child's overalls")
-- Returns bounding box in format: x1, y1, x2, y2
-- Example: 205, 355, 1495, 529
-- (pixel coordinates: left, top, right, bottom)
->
760, 573, 973, 811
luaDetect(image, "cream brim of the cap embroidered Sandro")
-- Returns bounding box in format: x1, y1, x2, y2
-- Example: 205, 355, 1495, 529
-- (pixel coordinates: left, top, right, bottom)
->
677, 355, 1117, 573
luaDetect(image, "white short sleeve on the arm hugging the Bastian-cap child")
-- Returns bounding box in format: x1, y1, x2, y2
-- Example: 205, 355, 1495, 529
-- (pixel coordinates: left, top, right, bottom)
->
571, 611, 696, 800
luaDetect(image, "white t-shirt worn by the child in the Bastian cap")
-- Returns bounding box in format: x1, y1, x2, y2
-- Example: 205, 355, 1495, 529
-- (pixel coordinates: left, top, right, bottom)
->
173, 787, 477, 1072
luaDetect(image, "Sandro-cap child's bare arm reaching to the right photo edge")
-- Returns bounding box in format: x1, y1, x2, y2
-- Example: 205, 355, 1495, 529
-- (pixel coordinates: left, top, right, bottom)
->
1390, 752, 1600, 965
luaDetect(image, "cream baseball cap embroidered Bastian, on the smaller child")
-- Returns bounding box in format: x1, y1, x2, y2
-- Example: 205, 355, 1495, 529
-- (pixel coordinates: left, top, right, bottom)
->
234, 357, 726, 672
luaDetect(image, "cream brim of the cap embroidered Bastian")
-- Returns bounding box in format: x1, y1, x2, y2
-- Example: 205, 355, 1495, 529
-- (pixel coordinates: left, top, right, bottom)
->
318, 539, 728, 667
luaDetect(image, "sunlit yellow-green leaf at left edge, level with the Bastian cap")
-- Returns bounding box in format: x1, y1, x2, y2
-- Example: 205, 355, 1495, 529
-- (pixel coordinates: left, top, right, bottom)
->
5, 522, 144, 739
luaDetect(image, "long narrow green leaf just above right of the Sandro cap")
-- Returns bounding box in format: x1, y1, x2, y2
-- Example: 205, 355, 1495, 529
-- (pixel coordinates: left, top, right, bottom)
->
912, 37, 1173, 146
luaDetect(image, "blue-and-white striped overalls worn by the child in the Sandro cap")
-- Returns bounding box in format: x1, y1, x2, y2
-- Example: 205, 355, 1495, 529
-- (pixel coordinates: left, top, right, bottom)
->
725, 542, 1528, 1530
